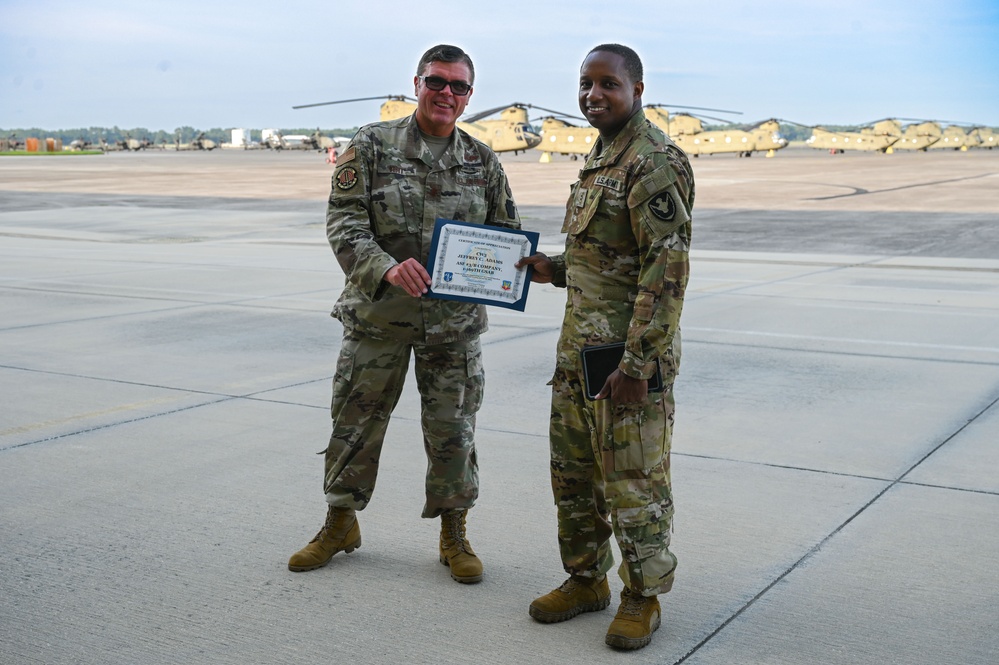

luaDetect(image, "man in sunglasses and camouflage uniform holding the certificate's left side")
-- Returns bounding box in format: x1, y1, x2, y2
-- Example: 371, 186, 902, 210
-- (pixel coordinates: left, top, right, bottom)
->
288, 44, 520, 583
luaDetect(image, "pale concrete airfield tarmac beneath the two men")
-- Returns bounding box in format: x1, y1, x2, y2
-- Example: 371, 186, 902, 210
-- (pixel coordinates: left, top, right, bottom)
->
0, 149, 999, 665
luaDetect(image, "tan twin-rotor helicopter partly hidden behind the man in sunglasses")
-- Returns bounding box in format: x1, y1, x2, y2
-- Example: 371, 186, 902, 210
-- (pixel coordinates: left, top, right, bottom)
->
292, 95, 541, 154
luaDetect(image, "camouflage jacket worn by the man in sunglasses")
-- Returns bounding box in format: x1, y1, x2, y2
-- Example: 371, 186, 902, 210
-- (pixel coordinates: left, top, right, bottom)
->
326, 116, 520, 344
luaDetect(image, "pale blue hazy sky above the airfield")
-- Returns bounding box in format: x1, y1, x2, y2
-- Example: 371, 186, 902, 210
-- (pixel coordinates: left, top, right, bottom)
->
0, 0, 999, 131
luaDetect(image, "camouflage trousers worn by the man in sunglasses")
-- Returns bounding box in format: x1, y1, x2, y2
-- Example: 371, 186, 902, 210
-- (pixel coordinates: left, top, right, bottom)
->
324, 332, 485, 517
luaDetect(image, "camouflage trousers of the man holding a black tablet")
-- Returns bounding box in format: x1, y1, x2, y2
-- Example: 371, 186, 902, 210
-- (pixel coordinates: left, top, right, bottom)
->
550, 368, 676, 596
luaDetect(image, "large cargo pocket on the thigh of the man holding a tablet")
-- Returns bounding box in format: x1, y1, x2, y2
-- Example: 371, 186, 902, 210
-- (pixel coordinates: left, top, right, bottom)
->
610, 394, 669, 471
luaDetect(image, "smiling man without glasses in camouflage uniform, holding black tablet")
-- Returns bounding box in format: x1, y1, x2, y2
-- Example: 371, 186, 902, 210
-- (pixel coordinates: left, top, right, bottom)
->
520, 44, 694, 649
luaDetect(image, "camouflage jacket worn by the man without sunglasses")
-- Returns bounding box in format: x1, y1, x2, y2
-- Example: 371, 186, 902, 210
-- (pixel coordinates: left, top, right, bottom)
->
552, 110, 694, 380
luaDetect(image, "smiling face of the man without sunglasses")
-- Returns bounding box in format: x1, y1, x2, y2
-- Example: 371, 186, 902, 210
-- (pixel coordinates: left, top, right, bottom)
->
579, 51, 645, 139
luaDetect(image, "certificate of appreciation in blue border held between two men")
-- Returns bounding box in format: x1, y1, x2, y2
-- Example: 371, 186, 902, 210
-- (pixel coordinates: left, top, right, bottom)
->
427, 219, 538, 311
